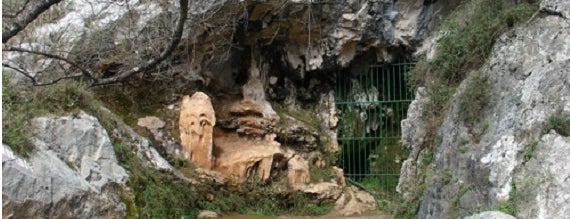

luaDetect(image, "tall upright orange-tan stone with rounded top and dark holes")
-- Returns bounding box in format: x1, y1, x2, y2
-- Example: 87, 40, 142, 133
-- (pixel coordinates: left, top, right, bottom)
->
179, 92, 216, 169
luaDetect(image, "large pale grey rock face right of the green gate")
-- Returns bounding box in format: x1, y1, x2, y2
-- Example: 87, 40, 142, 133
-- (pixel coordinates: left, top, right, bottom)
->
399, 1, 570, 218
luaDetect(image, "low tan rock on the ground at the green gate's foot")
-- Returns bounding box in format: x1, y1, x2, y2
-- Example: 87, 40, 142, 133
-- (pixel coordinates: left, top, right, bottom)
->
334, 186, 377, 216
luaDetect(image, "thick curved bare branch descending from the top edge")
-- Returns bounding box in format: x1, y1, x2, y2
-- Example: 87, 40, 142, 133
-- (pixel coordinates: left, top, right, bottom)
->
92, 0, 188, 86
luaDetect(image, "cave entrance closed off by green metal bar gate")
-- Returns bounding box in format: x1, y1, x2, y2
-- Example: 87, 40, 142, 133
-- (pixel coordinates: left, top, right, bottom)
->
336, 61, 413, 197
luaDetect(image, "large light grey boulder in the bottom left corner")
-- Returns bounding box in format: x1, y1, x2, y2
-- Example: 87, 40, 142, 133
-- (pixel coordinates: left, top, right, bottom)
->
2, 112, 128, 218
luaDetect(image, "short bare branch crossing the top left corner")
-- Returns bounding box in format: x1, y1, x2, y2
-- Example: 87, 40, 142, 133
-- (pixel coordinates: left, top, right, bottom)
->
2, 0, 62, 43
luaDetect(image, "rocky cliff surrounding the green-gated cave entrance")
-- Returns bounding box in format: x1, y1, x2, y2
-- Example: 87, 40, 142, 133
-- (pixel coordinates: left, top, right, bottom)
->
2, 0, 570, 218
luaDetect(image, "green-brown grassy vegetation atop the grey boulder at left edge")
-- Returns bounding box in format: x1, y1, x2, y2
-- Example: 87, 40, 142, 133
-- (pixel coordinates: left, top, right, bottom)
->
2, 74, 101, 157
